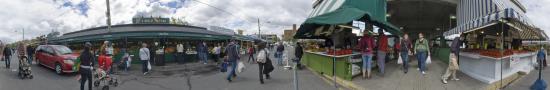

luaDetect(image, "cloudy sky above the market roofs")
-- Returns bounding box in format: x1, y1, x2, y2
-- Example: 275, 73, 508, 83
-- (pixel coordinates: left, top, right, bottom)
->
0, 0, 550, 42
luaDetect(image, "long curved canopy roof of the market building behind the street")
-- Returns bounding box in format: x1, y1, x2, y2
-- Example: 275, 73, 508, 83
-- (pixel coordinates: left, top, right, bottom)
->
51, 24, 232, 43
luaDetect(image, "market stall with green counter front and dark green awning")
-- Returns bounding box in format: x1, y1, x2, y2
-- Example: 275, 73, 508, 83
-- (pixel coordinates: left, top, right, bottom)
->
294, 0, 402, 84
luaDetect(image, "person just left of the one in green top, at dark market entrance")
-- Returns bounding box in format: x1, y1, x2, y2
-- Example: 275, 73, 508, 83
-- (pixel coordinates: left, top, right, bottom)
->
396, 33, 412, 74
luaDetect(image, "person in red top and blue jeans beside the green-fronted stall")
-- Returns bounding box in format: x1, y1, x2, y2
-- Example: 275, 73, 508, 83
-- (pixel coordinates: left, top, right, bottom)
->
358, 31, 374, 79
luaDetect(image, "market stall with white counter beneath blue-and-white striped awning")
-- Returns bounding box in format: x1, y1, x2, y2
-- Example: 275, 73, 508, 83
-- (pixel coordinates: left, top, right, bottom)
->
444, 0, 546, 84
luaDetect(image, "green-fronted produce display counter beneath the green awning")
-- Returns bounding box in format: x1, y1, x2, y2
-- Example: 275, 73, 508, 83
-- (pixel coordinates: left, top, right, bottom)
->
302, 51, 361, 80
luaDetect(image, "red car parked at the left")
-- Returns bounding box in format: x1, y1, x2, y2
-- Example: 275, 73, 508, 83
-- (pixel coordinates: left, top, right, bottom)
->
35, 45, 78, 74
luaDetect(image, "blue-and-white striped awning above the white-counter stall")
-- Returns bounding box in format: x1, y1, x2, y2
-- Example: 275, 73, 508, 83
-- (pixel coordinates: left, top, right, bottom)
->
443, 0, 544, 39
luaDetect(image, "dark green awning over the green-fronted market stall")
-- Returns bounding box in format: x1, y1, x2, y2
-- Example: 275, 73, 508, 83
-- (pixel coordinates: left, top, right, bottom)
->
294, 0, 402, 38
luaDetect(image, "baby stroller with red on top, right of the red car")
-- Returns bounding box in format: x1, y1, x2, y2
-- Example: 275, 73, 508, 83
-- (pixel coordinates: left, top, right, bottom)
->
93, 56, 118, 90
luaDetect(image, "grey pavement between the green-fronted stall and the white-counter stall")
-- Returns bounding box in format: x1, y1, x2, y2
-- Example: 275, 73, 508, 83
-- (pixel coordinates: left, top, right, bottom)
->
352, 56, 488, 90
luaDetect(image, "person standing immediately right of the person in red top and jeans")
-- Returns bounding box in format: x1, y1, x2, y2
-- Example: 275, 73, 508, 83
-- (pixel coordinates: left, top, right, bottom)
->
376, 29, 388, 76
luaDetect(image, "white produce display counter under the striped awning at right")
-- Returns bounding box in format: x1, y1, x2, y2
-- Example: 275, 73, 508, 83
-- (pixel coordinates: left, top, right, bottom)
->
459, 52, 536, 84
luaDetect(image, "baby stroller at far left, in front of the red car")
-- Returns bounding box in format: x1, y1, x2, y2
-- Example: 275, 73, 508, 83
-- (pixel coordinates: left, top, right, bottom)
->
18, 55, 33, 79
